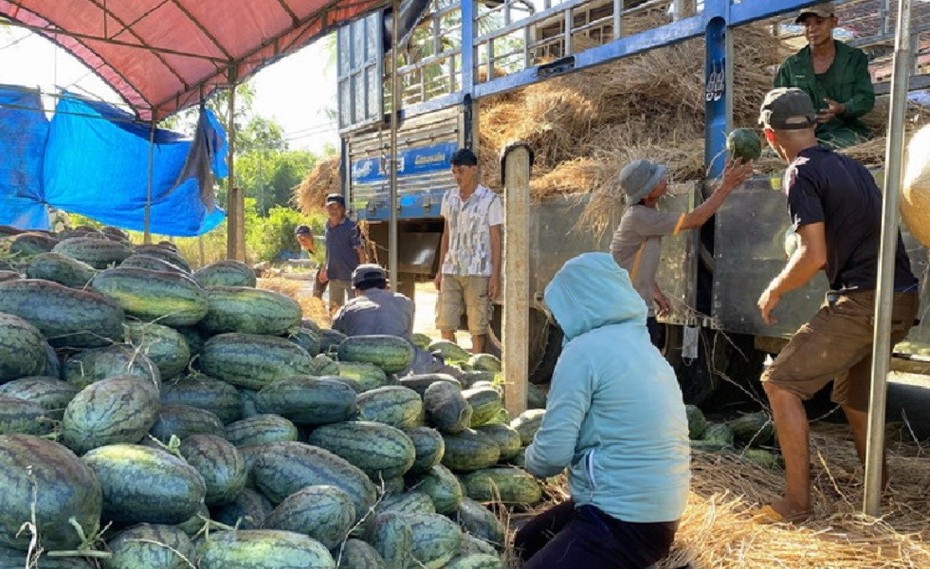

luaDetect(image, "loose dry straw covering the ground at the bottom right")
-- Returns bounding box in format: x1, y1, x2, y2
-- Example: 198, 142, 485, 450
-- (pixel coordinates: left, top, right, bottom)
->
500, 424, 930, 569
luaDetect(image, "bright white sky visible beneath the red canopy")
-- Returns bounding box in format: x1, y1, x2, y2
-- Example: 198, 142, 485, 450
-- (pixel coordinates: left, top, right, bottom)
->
0, 26, 339, 153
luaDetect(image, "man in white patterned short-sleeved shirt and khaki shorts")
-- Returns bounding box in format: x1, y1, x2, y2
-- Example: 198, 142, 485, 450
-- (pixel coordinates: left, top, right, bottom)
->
435, 148, 504, 354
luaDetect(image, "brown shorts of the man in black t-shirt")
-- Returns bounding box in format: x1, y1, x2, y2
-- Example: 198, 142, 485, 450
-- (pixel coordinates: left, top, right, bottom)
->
762, 291, 918, 411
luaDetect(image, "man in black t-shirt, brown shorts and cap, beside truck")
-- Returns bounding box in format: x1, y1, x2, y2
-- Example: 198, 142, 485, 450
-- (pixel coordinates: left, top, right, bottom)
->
758, 88, 918, 521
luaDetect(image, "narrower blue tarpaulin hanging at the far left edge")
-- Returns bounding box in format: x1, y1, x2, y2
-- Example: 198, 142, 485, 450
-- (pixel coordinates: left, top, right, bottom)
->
0, 85, 49, 229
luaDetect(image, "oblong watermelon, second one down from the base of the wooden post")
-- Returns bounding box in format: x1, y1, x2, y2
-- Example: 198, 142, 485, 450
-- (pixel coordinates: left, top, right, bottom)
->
198, 286, 300, 338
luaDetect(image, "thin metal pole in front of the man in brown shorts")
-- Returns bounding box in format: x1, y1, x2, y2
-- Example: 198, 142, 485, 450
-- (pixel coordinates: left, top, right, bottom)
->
862, 0, 911, 517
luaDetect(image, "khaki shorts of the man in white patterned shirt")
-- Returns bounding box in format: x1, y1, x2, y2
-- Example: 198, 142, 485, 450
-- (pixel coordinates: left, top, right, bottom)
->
436, 274, 491, 336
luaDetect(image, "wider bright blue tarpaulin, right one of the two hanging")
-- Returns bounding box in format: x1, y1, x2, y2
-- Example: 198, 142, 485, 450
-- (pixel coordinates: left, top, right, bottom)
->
0, 87, 227, 236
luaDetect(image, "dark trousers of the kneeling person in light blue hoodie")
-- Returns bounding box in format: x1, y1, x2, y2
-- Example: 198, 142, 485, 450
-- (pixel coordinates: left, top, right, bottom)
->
513, 500, 678, 569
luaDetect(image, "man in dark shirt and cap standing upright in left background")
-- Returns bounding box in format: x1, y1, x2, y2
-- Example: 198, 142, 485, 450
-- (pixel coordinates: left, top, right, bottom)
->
318, 194, 368, 314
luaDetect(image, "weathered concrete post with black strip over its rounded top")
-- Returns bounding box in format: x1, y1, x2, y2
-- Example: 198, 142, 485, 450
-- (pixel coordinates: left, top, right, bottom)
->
502, 142, 530, 417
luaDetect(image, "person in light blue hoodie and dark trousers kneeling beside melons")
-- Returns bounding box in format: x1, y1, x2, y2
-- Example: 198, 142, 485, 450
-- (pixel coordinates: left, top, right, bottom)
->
514, 253, 691, 569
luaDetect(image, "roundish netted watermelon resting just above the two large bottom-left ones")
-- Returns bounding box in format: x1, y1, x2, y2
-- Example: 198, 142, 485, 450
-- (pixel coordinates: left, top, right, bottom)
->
61, 375, 160, 454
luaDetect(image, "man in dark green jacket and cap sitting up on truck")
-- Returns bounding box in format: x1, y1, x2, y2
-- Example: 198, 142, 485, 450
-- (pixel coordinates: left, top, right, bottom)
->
775, 2, 875, 148
